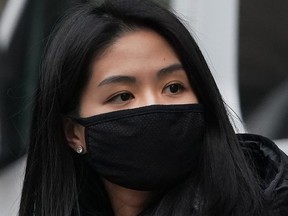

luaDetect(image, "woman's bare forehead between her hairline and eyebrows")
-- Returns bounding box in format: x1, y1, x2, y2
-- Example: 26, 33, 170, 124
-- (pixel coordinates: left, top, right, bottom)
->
92, 29, 180, 79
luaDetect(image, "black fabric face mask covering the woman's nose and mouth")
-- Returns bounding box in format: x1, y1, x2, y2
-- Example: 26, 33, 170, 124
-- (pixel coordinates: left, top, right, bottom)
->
76, 104, 205, 191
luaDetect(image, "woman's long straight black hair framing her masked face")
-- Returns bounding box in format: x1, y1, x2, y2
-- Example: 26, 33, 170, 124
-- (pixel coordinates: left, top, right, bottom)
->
19, 0, 265, 216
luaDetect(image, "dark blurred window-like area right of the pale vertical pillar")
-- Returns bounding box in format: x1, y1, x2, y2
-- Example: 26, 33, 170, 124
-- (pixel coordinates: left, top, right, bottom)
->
238, 0, 288, 139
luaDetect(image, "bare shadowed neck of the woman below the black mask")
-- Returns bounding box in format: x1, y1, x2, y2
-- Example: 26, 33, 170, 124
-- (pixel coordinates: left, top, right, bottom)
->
103, 179, 154, 216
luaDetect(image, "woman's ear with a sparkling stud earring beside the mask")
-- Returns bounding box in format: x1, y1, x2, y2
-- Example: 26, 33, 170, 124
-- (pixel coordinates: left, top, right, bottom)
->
63, 118, 86, 153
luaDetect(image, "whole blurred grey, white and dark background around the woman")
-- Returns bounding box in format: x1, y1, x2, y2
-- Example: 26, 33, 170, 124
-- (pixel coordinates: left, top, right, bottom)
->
0, 0, 288, 216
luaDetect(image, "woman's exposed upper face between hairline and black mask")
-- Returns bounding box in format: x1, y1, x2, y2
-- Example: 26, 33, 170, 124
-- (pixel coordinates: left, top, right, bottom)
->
79, 29, 198, 117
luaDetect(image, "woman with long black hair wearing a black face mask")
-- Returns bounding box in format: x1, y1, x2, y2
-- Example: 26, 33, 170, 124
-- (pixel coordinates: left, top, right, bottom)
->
19, 0, 288, 216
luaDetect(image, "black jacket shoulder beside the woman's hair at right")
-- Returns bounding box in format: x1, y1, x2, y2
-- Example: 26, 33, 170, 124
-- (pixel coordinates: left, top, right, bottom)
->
237, 134, 288, 216
